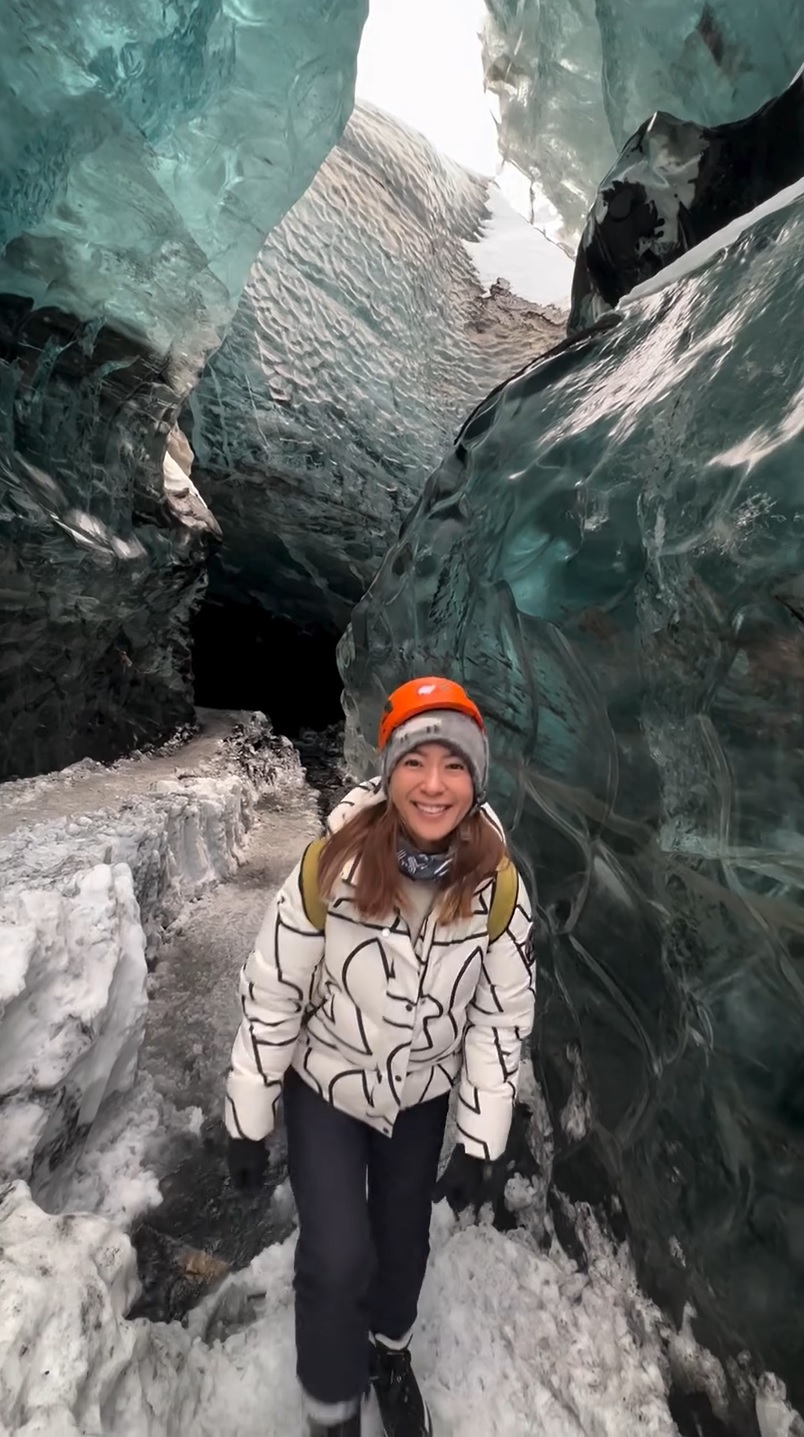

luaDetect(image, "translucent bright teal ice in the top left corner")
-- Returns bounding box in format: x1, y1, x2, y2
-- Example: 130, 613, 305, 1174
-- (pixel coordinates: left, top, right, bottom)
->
0, 0, 368, 372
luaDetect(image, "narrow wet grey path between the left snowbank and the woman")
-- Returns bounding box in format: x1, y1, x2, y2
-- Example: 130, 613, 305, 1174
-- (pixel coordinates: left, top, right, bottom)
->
135, 786, 321, 1318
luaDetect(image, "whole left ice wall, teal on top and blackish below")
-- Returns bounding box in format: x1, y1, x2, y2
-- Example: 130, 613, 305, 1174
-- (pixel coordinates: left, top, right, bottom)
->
0, 0, 367, 777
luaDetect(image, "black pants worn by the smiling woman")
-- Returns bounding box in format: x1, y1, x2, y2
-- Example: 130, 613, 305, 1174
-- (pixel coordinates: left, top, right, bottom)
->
285, 1069, 449, 1403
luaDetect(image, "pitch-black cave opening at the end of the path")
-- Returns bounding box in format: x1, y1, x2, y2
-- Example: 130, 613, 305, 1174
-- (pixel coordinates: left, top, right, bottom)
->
191, 593, 344, 739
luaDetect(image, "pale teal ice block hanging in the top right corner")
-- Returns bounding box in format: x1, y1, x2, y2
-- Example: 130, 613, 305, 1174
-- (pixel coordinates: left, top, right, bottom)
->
485, 0, 801, 234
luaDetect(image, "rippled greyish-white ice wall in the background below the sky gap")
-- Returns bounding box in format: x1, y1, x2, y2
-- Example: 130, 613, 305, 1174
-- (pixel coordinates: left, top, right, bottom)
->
188, 105, 566, 628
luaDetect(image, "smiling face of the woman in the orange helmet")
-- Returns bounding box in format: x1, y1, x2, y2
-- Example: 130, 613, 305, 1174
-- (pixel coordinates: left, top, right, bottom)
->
388, 743, 475, 854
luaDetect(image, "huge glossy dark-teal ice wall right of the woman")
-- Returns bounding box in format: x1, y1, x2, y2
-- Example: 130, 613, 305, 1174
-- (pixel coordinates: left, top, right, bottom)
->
341, 185, 804, 1404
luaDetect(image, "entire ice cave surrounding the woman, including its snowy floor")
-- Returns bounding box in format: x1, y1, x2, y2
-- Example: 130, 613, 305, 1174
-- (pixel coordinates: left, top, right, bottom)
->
0, 0, 804, 1437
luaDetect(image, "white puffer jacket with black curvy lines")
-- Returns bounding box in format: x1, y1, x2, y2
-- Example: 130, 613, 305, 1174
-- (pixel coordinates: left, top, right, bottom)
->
226, 779, 534, 1160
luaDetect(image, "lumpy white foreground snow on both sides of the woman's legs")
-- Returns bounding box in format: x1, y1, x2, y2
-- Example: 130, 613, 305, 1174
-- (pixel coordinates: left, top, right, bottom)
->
0, 1166, 795, 1437
